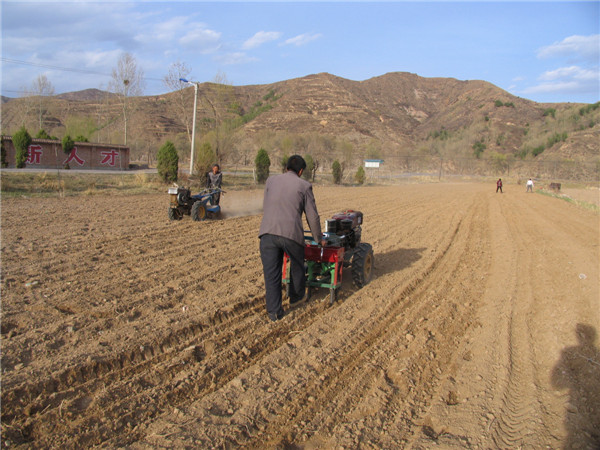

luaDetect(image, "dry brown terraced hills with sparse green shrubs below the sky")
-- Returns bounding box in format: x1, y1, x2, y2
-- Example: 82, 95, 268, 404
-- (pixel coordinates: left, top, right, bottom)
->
2, 72, 600, 178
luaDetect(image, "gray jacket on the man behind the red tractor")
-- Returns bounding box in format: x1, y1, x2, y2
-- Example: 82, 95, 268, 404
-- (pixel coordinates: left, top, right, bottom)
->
258, 170, 321, 245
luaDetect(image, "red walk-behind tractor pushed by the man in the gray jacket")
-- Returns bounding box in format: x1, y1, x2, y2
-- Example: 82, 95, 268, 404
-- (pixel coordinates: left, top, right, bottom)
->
282, 209, 375, 304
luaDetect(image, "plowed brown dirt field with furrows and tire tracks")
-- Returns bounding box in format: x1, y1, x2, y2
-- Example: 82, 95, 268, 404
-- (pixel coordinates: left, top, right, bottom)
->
1, 184, 600, 449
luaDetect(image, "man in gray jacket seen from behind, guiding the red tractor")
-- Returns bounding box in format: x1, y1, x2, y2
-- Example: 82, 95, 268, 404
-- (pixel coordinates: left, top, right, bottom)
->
258, 155, 324, 322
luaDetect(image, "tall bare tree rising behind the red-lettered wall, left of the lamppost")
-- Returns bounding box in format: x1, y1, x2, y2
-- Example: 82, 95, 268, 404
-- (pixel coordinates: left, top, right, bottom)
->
108, 52, 145, 145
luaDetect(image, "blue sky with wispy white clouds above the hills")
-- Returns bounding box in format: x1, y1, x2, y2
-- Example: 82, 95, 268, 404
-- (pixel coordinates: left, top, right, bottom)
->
1, 0, 600, 103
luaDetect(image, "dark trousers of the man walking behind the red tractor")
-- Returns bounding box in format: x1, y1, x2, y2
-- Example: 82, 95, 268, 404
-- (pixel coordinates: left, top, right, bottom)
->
260, 234, 306, 316
